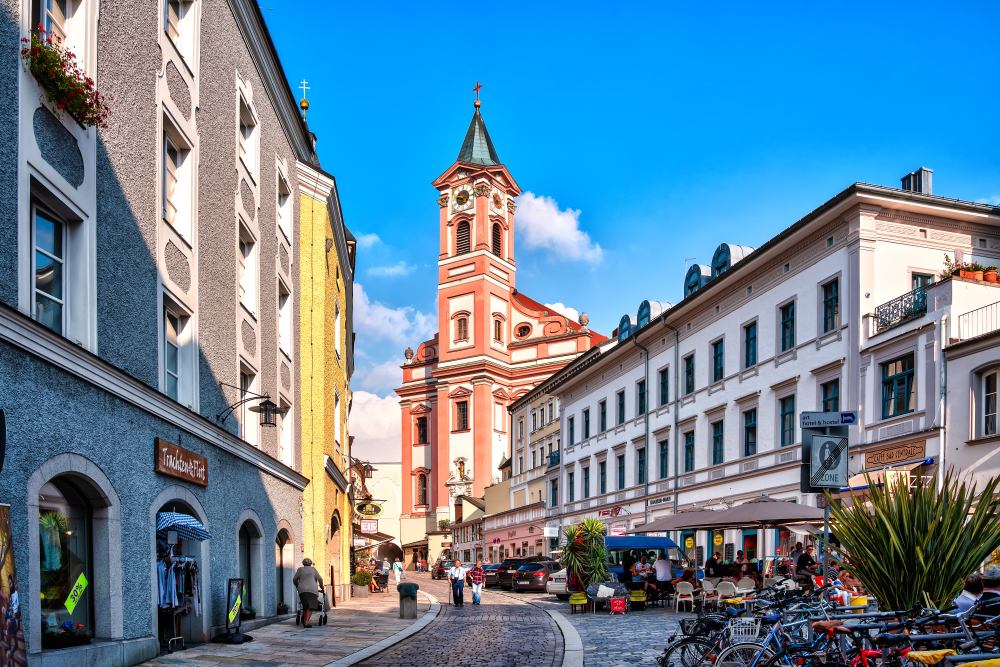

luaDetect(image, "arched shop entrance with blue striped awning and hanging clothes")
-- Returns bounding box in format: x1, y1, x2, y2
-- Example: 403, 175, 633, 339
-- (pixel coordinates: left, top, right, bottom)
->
156, 500, 211, 647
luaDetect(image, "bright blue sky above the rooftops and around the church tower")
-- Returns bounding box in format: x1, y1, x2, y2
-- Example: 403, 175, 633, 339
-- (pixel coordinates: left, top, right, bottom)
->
261, 0, 1000, 460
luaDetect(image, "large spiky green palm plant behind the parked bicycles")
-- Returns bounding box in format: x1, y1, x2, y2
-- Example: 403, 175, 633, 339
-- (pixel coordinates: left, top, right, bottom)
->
827, 470, 1000, 610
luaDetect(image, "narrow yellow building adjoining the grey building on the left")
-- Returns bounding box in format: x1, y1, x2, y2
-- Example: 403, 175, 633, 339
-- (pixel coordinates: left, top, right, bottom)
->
296, 162, 357, 605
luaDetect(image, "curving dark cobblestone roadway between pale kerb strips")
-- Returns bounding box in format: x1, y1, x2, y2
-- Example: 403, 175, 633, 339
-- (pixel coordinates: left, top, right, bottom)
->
358, 574, 563, 667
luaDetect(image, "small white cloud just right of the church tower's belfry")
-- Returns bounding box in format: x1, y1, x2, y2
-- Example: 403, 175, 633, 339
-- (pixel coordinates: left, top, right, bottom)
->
516, 192, 604, 262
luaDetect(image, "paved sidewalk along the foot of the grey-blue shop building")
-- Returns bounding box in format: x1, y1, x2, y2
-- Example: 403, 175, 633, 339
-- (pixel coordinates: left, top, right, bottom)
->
142, 584, 430, 667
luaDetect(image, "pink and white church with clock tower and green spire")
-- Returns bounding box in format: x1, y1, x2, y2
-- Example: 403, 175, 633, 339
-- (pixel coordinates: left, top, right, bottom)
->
396, 101, 606, 568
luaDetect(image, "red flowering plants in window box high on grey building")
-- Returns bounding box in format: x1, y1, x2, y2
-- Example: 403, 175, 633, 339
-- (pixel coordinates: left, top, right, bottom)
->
21, 25, 112, 129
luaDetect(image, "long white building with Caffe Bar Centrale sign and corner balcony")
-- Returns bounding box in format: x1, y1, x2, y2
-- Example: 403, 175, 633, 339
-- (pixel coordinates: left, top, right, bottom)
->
540, 170, 1000, 564
